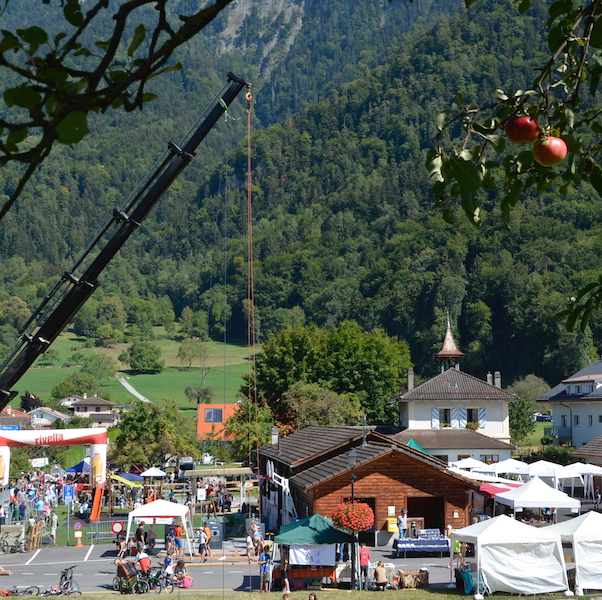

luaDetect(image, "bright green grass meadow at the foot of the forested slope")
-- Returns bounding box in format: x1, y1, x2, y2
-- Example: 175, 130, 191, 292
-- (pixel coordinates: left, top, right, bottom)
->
12, 328, 252, 408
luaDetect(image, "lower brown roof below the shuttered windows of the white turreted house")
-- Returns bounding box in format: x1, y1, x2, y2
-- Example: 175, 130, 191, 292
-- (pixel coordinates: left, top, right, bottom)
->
392, 427, 514, 450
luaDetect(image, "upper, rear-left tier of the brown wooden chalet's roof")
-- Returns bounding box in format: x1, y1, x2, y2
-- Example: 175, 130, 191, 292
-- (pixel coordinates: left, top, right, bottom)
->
259, 425, 371, 466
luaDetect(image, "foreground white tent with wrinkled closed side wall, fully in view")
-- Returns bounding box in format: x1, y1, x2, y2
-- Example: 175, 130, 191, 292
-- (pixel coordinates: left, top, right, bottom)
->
451, 515, 568, 594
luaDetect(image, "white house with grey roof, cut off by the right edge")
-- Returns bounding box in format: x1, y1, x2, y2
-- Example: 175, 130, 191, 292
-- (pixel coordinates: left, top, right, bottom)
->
537, 360, 602, 448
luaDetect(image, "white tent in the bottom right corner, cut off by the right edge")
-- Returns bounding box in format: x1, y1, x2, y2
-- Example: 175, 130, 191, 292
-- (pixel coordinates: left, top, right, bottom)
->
543, 511, 602, 596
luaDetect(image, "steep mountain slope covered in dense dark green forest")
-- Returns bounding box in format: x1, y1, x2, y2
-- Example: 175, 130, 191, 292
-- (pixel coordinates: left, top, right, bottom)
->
0, 0, 602, 383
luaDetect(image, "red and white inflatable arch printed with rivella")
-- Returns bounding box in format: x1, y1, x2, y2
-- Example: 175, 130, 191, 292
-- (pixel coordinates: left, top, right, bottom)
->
0, 427, 107, 487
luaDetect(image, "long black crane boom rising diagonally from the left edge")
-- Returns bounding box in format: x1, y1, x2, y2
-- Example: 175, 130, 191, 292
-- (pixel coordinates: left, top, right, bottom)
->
0, 73, 250, 410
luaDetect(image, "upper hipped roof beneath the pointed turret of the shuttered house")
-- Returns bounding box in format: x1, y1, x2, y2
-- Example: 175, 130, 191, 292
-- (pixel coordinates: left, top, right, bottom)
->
389, 367, 518, 404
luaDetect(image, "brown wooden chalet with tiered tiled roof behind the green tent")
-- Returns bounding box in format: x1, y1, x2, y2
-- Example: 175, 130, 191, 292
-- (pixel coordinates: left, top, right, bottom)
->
259, 426, 478, 543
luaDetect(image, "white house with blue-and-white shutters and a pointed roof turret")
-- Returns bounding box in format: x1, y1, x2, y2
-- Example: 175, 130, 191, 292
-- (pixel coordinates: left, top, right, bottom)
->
390, 324, 519, 462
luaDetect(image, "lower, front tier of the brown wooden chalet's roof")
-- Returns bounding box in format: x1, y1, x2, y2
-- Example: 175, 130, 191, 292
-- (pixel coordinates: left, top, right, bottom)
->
290, 442, 478, 491
